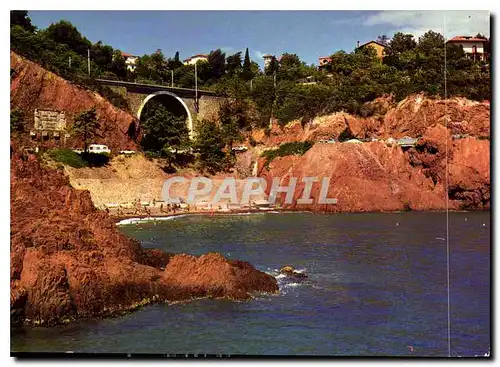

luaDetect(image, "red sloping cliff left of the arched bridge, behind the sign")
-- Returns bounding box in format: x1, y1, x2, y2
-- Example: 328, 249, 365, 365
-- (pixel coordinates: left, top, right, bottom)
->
10, 51, 139, 151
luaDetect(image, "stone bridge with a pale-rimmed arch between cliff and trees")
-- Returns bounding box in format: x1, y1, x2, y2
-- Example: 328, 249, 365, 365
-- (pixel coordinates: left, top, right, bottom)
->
96, 79, 223, 138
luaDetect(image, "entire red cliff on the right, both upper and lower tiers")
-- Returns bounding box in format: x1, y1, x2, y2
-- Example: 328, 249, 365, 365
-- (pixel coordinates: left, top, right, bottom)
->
255, 96, 491, 212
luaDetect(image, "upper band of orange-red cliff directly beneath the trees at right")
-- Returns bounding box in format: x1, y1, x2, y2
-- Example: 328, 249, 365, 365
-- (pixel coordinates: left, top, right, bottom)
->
253, 95, 490, 146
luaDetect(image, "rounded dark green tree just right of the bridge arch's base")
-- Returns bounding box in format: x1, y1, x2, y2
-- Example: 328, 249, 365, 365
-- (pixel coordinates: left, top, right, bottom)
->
194, 120, 227, 174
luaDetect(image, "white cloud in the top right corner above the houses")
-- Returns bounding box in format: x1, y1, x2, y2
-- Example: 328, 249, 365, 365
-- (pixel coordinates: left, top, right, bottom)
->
362, 10, 490, 38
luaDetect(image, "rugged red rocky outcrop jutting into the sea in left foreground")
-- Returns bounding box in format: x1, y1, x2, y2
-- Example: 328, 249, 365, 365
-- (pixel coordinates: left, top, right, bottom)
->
11, 153, 278, 325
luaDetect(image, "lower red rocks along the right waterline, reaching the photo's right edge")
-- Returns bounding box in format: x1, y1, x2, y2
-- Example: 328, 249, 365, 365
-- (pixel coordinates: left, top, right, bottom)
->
260, 124, 490, 212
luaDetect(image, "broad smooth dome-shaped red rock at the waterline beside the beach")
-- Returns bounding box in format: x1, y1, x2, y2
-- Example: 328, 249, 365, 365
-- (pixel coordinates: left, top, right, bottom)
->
261, 142, 445, 212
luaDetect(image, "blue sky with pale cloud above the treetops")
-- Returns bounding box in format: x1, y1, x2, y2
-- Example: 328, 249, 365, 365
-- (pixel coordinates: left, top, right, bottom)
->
29, 10, 490, 67
